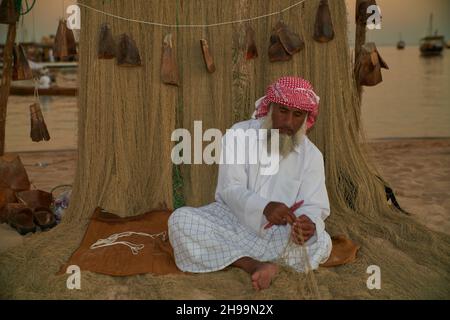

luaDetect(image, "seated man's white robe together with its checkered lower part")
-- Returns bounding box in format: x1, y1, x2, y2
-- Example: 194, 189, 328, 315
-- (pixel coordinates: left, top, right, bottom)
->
169, 119, 331, 272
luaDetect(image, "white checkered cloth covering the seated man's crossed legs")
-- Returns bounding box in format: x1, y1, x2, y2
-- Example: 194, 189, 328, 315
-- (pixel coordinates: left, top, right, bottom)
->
169, 202, 331, 273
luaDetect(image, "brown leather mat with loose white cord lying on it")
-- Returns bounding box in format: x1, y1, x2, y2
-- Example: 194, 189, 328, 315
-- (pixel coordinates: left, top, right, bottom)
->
59, 208, 182, 276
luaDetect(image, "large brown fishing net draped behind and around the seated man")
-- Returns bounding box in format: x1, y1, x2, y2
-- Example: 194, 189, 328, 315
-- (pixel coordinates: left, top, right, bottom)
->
0, 0, 450, 299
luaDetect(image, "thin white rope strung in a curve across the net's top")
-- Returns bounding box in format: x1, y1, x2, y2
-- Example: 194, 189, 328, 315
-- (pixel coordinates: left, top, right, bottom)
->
77, 0, 306, 28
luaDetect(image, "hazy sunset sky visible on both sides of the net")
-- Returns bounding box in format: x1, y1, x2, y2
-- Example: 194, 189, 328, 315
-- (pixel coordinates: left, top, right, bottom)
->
0, 0, 450, 46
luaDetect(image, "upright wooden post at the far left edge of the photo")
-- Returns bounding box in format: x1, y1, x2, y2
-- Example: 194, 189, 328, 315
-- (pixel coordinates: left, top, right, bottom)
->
0, 23, 16, 156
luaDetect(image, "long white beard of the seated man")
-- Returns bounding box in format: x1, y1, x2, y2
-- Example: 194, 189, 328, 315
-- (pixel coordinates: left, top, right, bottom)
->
261, 108, 308, 158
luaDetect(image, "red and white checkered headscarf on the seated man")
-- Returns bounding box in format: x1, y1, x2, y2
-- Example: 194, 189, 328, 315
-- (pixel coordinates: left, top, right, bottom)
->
254, 77, 320, 129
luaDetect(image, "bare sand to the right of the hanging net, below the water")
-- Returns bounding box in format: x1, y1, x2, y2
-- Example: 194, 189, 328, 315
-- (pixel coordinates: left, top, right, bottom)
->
370, 139, 450, 234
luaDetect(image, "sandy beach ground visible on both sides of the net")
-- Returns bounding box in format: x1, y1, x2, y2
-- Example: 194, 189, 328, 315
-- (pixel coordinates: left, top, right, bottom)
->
0, 139, 450, 252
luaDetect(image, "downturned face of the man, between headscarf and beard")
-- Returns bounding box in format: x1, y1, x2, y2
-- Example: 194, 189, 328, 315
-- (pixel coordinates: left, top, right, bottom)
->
272, 103, 308, 136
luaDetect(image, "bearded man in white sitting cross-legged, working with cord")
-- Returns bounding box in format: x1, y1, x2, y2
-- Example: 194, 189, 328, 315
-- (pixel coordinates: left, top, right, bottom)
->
169, 77, 331, 290
